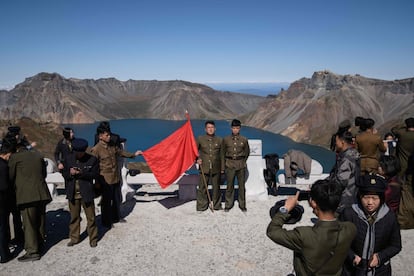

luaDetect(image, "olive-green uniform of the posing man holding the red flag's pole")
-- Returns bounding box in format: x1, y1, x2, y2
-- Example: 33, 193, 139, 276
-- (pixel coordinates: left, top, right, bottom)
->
197, 135, 224, 211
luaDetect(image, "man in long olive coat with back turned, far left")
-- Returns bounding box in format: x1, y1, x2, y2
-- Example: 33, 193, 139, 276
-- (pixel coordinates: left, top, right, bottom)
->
9, 144, 52, 262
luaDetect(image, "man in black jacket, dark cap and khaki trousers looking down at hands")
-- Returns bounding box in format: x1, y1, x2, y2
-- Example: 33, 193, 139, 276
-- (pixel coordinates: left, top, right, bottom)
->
62, 138, 99, 247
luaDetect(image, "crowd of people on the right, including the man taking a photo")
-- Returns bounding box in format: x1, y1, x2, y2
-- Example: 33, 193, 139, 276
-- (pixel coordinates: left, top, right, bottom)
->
267, 117, 414, 275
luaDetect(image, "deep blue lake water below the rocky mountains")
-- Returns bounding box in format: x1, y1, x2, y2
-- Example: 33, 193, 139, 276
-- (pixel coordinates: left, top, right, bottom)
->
68, 119, 335, 172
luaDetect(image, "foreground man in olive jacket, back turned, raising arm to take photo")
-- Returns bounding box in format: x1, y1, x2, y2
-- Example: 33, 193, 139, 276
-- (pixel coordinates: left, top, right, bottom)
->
267, 180, 356, 276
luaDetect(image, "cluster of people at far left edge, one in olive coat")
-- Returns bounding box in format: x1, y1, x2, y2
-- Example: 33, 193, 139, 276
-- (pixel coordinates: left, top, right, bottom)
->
0, 126, 52, 263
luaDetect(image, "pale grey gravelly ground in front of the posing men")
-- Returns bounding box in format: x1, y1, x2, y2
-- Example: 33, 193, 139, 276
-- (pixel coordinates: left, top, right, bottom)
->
0, 185, 414, 275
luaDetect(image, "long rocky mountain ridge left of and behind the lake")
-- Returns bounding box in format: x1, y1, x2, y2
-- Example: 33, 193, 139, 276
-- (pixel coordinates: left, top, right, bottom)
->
0, 73, 266, 123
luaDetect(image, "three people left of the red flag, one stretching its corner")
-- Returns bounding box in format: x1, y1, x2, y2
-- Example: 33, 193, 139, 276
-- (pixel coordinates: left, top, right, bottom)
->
55, 122, 142, 247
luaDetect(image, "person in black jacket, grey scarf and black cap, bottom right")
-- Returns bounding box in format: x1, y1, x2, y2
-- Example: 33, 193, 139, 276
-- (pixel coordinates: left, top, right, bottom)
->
343, 174, 401, 275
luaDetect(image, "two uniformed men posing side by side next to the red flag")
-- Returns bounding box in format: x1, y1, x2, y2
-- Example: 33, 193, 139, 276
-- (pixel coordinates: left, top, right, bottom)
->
196, 119, 250, 212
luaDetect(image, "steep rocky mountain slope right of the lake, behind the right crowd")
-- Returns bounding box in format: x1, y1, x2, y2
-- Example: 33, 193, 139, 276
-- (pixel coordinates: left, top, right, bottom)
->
244, 71, 414, 146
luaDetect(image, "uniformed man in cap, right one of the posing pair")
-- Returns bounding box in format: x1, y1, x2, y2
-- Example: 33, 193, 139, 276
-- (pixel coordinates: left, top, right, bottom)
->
223, 119, 250, 212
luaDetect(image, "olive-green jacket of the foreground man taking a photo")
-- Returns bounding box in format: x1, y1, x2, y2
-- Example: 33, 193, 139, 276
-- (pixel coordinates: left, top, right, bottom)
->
267, 212, 356, 276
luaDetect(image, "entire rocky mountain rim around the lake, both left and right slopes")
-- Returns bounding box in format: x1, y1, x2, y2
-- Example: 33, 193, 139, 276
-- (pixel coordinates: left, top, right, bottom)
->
0, 71, 414, 147
